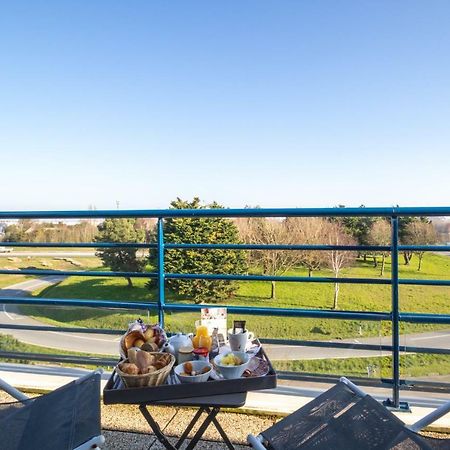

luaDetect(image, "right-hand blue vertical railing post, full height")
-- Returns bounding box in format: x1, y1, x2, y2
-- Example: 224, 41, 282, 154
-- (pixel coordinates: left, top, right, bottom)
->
391, 216, 400, 409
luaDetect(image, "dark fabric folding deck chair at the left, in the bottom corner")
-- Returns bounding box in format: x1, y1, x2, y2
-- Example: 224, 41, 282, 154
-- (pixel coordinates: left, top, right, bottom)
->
0, 370, 105, 450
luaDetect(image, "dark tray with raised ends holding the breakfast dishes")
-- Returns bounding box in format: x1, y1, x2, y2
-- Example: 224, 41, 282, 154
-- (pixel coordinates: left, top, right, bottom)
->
103, 348, 277, 405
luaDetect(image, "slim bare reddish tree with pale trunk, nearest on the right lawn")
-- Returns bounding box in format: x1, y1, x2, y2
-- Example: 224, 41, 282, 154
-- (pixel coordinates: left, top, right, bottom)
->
327, 222, 355, 309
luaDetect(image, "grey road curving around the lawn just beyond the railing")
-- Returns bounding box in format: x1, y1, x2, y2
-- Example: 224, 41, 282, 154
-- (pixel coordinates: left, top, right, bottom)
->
0, 276, 450, 360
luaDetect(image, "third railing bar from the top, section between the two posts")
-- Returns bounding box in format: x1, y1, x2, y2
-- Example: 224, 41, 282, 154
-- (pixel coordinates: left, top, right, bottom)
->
167, 272, 391, 284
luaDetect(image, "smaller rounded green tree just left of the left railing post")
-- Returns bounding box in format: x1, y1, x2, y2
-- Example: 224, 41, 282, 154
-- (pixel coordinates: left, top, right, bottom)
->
95, 219, 145, 287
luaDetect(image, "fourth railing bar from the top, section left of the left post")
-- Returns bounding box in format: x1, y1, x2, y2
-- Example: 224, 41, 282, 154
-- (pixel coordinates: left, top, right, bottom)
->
0, 296, 158, 310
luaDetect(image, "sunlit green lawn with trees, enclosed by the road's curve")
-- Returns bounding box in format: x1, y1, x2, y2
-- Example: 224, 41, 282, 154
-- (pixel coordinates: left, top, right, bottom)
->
18, 254, 450, 340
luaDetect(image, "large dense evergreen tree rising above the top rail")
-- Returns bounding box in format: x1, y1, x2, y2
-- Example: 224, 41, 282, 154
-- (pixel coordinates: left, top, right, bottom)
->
164, 197, 247, 303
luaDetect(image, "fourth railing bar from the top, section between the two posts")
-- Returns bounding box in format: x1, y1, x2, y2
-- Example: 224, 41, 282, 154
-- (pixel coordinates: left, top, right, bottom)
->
163, 299, 391, 321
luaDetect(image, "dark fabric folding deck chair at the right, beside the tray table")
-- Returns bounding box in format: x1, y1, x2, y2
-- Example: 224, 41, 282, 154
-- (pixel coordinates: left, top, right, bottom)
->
248, 378, 450, 450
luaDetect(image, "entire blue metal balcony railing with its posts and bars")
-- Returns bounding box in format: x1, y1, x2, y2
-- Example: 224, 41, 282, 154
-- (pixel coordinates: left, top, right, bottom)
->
0, 207, 450, 407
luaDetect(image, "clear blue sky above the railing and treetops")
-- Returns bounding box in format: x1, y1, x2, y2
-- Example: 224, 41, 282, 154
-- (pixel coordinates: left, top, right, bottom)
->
0, 0, 450, 210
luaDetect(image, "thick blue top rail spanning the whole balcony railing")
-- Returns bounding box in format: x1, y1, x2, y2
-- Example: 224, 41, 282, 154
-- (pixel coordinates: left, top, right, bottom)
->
0, 207, 450, 219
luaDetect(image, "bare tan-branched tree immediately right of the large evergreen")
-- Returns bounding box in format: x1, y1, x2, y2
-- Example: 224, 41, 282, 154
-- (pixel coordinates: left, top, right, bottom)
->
238, 217, 301, 298
